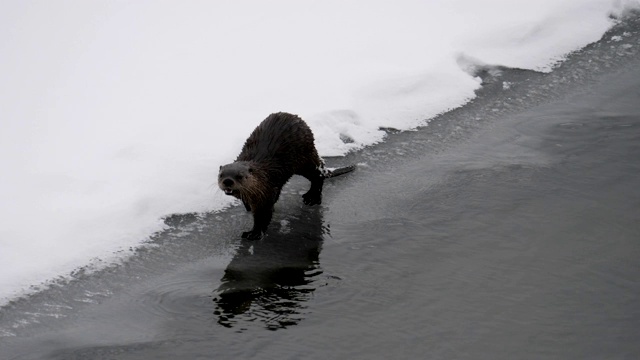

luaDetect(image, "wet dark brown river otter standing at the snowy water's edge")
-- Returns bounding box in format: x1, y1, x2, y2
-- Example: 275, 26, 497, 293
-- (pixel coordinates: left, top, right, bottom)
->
218, 112, 355, 240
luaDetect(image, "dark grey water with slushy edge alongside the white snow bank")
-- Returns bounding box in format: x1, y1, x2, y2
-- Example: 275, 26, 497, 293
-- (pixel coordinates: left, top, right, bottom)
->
0, 15, 640, 359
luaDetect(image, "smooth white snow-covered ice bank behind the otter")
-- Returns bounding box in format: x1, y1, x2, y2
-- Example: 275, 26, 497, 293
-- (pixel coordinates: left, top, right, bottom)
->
0, 0, 637, 301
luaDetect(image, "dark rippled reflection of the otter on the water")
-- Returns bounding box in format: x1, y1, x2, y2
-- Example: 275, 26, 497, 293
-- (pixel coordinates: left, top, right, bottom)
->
213, 207, 326, 330
